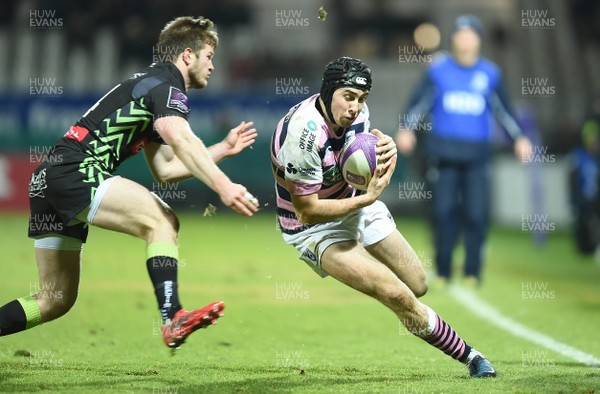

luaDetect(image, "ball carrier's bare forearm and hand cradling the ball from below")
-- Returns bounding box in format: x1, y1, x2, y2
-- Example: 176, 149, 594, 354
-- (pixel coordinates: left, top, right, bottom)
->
289, 155, 397, 224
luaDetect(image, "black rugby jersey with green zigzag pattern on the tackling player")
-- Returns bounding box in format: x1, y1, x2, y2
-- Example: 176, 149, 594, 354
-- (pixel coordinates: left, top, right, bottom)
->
54, 62, 190, 174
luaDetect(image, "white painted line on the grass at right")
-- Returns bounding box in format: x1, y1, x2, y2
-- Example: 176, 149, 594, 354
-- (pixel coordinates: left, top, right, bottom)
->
450, 286, 600, 368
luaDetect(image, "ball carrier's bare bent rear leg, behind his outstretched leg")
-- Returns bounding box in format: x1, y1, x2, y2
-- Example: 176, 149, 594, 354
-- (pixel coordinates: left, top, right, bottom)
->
365, 230, 427, 297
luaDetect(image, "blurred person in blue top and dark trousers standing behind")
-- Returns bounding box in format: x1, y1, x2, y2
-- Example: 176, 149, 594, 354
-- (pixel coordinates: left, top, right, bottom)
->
397, 15, 532, 286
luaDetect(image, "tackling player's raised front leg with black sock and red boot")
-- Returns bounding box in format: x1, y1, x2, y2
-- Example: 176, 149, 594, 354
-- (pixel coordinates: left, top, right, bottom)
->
88, 178, 224, 348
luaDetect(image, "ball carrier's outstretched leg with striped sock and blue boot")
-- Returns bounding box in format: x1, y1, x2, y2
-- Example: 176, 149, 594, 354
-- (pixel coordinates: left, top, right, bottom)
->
321, 241, 496, 377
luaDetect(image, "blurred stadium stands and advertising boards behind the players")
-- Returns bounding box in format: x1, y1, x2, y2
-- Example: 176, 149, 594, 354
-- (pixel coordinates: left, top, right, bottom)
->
0, 0, 600, 246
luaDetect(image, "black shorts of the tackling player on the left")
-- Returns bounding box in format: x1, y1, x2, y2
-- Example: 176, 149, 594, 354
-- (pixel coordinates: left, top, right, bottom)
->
29, 148, 112, 243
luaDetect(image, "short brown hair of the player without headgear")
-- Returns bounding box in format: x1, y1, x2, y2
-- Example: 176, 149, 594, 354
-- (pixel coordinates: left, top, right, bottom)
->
156, 16, 219, 61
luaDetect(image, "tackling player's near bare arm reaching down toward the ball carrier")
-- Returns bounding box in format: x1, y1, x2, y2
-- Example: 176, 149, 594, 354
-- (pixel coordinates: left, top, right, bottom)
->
154, 116, 257, 216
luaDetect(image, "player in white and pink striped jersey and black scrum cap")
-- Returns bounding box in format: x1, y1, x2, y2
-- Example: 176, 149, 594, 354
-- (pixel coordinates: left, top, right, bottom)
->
271, 57, 496, 378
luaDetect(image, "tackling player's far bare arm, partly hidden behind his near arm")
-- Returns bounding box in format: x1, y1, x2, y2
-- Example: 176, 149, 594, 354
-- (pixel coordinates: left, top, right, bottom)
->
144, 122, 257, 182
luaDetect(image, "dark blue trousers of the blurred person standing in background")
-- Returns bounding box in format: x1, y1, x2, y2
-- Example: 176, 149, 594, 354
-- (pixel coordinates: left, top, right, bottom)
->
429, 160, 490, 279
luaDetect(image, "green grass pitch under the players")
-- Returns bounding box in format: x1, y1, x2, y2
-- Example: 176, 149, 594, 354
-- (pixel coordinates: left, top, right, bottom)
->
0, 213, 600, 393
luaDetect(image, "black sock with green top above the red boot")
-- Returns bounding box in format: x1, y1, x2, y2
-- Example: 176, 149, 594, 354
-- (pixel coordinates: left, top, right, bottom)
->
146, 243, 181, 324
